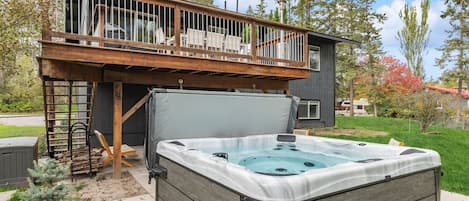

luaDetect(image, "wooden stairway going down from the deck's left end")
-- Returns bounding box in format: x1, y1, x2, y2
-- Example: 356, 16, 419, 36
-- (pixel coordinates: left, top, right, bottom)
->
43, 80, 97, 173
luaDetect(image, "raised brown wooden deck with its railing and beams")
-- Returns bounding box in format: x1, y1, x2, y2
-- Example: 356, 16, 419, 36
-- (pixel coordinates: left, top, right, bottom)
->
39, 0, 310, 90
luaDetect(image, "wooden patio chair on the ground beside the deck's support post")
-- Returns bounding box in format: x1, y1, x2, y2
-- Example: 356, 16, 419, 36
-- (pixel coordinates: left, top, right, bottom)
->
94, 130, 137, 167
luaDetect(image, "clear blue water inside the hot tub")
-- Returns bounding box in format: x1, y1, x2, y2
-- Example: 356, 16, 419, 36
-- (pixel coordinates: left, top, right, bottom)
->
205, 143, 351, 176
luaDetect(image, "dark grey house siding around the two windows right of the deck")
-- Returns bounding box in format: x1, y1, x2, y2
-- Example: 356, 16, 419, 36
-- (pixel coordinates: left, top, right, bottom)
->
290, 37, 336, 128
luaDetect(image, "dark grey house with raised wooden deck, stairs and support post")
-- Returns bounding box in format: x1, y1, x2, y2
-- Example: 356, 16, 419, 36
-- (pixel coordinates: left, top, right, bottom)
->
38, 0, 354, 175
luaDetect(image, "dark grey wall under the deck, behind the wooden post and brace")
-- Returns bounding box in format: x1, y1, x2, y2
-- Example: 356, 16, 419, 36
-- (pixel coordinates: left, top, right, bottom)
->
93, 83, 148, 145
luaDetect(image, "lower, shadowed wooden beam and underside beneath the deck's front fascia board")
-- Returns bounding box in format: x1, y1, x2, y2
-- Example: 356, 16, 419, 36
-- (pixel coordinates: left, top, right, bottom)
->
40, 58, 288, 90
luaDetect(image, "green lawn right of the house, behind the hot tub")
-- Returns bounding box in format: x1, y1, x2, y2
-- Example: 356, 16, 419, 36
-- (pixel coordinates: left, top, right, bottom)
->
325, 117, 469, 195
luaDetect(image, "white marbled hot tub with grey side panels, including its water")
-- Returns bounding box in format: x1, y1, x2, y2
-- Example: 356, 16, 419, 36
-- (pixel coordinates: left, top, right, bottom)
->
157, 134, 441, 201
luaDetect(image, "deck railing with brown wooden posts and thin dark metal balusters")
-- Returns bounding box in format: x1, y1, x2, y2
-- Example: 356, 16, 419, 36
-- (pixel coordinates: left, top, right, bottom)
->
43, 0, 308, 68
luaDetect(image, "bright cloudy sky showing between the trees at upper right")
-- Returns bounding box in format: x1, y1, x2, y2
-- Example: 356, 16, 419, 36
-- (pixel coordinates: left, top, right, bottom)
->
377, 0, 448, 79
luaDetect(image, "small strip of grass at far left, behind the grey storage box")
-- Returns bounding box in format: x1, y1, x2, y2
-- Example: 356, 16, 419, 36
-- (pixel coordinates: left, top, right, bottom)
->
0, 124, 46, 138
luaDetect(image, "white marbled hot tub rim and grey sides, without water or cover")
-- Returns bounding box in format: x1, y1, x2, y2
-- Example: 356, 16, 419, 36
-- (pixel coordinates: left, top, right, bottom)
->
157, 135, 440, 201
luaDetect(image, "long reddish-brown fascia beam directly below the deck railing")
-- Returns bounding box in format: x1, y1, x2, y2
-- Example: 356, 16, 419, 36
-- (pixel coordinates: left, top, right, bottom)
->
41, 41, 310, 79
